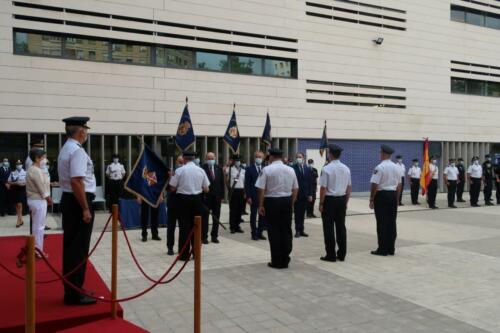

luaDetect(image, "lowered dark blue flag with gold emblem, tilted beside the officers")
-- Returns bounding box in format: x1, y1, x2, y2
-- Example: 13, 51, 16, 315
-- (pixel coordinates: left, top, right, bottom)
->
125, 145, 168, 208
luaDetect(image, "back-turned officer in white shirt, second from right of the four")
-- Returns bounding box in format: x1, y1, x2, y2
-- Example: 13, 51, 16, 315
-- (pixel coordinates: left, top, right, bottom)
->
319, 145, 352, 262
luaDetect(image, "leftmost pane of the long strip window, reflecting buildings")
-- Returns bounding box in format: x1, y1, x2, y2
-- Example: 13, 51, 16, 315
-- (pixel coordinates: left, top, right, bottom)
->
14, 32, 62, 57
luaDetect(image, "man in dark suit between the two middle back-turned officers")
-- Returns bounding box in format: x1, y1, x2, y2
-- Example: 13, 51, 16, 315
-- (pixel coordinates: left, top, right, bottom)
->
293, 153, 312, 238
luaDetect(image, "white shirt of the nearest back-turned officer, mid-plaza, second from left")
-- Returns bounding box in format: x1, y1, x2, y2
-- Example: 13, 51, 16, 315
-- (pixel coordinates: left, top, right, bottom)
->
255, 161, 299, 198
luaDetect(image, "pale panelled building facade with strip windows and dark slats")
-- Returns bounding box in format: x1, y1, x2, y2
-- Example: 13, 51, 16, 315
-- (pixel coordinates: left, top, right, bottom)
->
0, 0, 500, 192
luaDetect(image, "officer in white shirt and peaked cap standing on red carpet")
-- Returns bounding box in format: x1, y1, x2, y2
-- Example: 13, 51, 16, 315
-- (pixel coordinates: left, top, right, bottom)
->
57, 117, 96, 305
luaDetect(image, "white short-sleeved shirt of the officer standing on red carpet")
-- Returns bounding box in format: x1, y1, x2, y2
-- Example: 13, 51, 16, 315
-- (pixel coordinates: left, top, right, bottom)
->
57, 138, 96, 193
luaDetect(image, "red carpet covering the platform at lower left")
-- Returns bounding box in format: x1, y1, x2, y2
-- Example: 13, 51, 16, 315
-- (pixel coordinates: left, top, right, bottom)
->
0, 234, 125, 333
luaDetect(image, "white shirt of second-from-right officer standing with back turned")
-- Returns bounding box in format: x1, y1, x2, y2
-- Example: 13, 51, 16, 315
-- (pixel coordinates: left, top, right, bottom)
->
319, 160, 352, 197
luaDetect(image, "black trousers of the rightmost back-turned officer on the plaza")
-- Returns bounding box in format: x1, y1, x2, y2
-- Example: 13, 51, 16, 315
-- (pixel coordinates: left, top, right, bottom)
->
374, 191, 398, 253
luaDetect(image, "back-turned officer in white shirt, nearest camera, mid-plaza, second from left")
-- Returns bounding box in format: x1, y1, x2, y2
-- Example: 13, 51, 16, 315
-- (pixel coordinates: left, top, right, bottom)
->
255, 148, 299, 269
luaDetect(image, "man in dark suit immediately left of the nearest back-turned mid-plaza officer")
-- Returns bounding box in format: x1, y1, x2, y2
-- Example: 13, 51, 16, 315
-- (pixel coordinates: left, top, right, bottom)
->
245, 151, 266, 240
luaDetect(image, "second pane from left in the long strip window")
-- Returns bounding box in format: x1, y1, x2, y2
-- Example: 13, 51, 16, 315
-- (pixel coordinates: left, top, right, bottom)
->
64, 37, 109, 61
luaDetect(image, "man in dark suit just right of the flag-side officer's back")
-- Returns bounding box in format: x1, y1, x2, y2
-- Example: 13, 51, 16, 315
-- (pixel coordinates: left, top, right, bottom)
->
202, 152, 224, 244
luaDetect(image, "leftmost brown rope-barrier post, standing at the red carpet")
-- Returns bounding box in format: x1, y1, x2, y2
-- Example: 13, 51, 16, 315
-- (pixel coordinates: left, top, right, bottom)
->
24, 236, 36, 333
